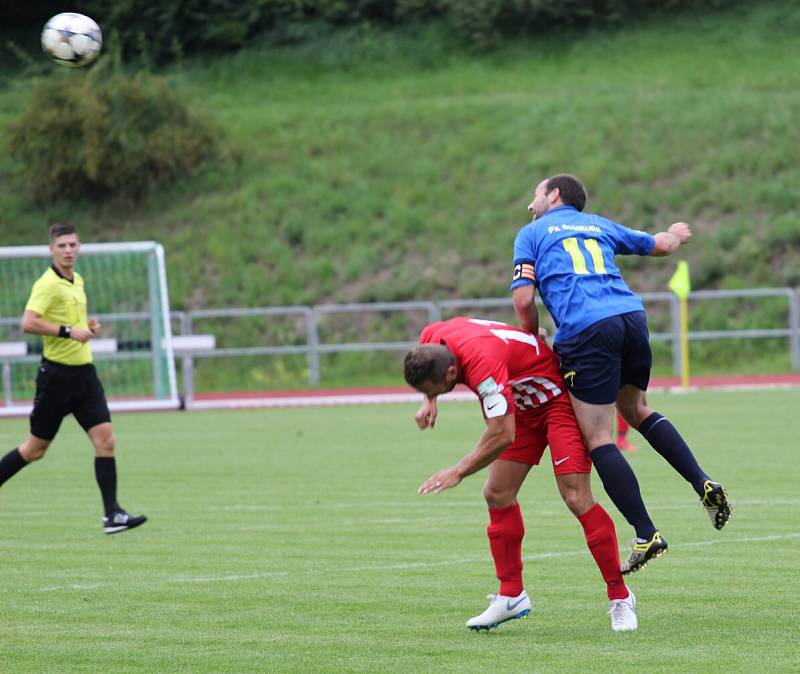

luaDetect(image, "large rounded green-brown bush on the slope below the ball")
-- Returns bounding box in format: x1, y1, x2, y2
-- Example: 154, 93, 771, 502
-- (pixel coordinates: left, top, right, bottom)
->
6, 69, 219, 202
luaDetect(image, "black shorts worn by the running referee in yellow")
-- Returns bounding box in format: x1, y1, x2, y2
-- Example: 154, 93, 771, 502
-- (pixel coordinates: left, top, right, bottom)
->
31, 358, 111, 440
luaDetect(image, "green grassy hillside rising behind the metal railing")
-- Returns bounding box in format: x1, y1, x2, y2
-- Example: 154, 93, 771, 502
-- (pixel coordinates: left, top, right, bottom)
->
0, 2, 800, 386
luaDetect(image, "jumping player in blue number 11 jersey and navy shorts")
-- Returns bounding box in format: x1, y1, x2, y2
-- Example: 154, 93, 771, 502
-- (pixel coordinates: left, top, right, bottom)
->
511, 174, 731, 573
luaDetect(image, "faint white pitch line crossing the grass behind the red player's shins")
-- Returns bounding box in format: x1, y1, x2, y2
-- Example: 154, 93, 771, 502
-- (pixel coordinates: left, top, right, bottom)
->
28, 532, 800, 592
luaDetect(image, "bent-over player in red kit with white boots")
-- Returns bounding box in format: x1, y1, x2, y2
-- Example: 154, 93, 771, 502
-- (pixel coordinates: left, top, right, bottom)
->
405, 317, 637, 631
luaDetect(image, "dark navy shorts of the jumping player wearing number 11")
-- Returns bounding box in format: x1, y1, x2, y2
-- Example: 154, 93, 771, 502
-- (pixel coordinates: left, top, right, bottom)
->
555, 311, 653, 405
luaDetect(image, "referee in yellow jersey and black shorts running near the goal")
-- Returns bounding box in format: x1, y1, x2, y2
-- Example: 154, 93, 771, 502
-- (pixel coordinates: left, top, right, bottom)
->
0, 223, 147, 534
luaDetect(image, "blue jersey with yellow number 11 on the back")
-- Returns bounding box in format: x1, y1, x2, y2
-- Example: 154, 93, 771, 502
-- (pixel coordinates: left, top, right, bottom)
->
511, 206, 656, 343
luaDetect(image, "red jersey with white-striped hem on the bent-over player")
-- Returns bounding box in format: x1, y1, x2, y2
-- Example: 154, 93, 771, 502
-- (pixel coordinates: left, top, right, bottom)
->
419, 316, 565, 416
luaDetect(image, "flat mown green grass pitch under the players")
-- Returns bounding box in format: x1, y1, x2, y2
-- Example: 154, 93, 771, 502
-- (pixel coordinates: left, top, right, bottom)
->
0, 389, 800, 673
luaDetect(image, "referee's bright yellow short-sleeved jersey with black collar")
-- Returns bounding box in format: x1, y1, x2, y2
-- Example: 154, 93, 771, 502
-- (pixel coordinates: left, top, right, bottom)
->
25, 267, 92, 365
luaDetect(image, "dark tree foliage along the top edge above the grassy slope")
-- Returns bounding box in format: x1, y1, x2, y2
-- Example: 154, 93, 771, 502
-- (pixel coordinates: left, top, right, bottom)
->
0, 0, 735, 62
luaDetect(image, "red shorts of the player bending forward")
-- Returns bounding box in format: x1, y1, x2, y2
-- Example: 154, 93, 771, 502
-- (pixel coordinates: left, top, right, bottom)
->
498, 393, 592, 475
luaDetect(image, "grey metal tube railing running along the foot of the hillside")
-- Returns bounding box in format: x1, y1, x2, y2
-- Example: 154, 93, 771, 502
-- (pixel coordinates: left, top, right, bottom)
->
0, 288, 800, 401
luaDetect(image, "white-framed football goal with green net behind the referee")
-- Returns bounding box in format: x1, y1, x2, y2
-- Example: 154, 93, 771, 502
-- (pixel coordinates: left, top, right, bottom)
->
0, 241, 180, 416
